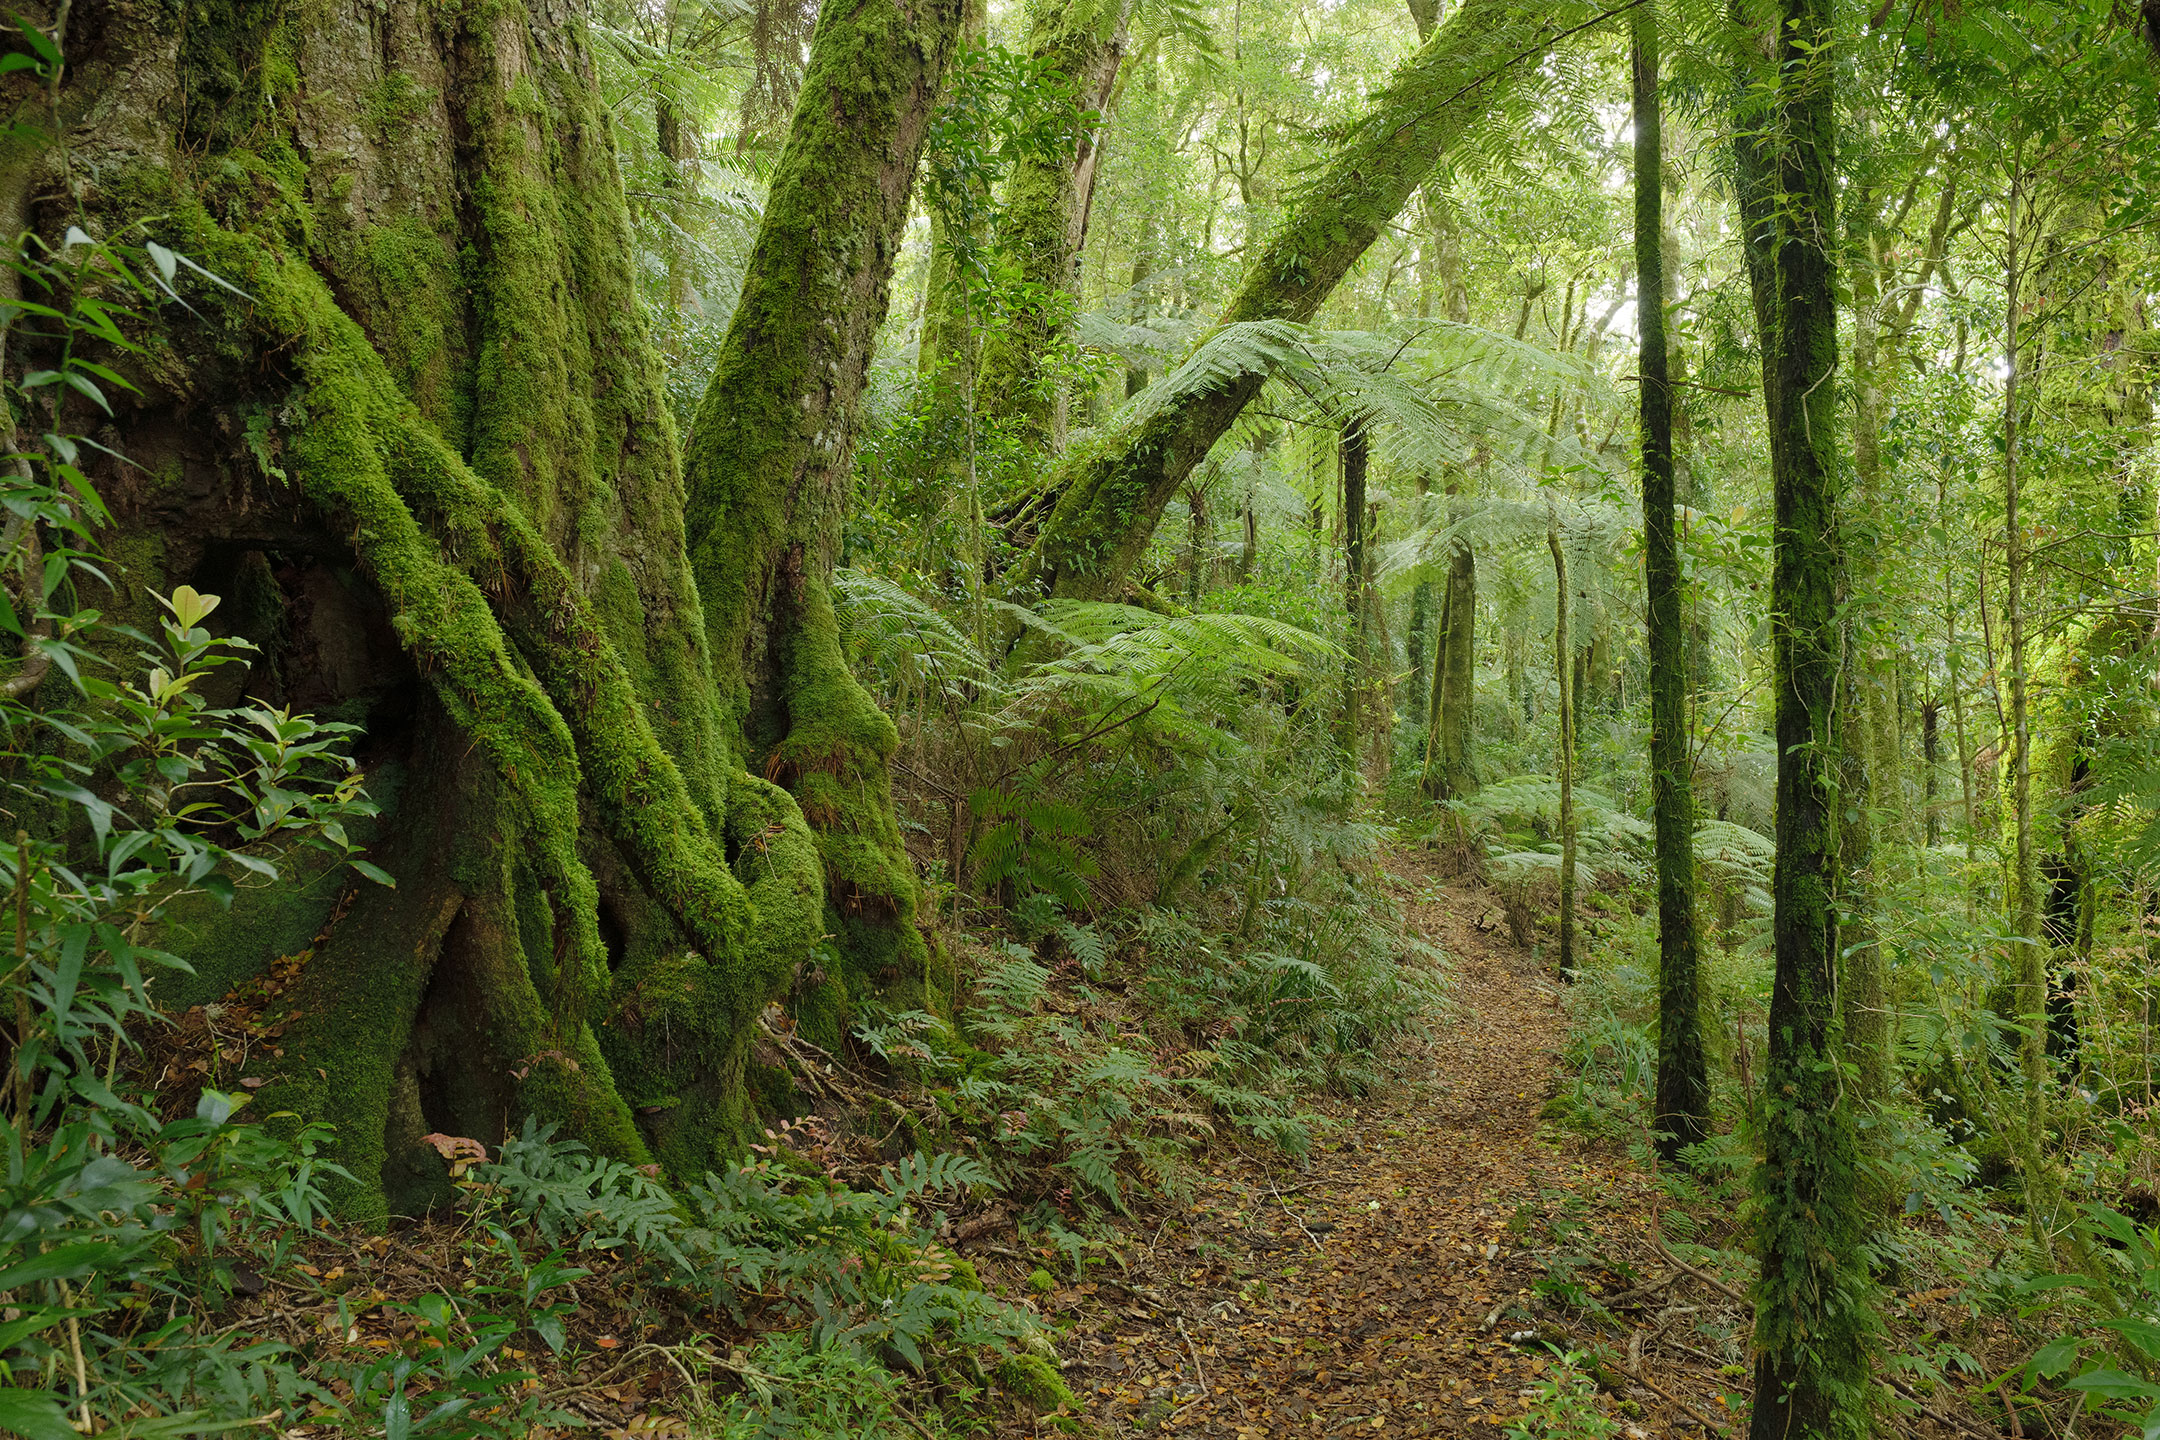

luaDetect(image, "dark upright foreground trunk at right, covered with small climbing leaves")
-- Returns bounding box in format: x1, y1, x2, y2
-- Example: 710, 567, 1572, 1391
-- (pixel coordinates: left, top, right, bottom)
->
1734, 0, 1873, 1440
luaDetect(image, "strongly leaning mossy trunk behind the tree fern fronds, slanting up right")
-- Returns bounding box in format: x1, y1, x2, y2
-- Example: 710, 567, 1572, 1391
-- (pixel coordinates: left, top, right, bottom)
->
1013, 0, 1581, 613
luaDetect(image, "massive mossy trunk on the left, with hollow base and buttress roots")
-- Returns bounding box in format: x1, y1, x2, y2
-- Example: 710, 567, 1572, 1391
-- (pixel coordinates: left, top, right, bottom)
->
44, 0, 821, 1218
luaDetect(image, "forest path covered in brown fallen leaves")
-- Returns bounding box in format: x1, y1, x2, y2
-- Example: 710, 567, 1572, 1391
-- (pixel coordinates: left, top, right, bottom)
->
1050, 853, 1739, 1440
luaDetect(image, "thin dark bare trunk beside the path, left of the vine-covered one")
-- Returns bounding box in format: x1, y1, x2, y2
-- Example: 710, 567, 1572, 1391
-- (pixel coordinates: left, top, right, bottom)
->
1633, 4, 1711, 1164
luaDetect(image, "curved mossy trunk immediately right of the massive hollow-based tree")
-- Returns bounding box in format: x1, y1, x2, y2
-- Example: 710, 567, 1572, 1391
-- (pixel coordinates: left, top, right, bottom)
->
685, 0, 961, 1019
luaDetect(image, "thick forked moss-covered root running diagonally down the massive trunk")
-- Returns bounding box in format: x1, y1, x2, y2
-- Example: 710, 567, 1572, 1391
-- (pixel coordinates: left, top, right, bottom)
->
235, 231, 821, 1172
